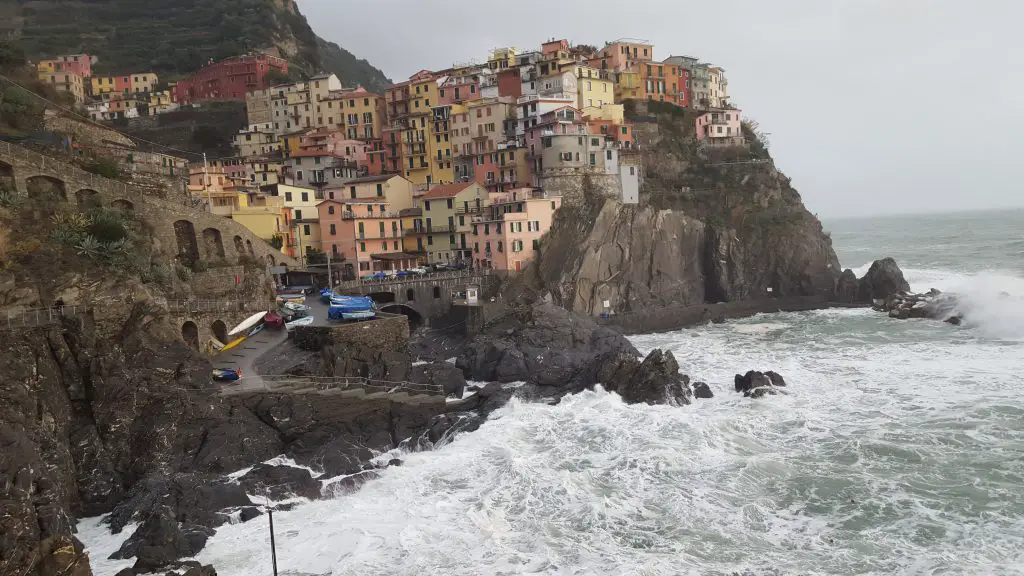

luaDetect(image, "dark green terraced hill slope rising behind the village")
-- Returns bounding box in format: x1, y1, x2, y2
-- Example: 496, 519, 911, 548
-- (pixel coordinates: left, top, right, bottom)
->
17, 0, 390, 88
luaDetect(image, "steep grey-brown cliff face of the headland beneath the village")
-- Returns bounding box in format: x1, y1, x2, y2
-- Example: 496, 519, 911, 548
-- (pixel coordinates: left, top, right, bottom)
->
527, 103, 841, 315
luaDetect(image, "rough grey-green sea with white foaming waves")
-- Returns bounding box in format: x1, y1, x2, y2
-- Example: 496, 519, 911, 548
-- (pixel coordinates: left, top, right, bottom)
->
79, 211, 1024, 576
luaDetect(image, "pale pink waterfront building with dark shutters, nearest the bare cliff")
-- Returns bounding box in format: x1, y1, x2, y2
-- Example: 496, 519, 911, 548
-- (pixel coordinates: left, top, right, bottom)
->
472, 189, 562, 272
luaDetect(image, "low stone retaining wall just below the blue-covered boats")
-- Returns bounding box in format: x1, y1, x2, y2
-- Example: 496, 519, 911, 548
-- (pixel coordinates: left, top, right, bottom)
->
292, 313, 409, 352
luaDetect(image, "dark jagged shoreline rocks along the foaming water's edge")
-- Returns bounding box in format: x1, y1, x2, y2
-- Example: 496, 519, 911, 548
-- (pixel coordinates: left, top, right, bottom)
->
0, 256, 905, 576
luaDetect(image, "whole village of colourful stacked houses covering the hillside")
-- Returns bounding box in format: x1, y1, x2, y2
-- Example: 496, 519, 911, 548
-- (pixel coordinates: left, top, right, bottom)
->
37, 39, 746, 278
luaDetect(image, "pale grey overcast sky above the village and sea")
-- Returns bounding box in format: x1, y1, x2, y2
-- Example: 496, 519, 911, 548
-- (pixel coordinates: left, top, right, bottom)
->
298, 0, 1024, 217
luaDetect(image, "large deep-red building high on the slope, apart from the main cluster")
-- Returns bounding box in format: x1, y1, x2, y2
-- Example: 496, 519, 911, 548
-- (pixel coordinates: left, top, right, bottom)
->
174, 54, 288, 104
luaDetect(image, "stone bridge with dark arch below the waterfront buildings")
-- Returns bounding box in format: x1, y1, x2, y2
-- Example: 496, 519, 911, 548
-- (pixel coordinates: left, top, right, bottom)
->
335, 271, 496, 327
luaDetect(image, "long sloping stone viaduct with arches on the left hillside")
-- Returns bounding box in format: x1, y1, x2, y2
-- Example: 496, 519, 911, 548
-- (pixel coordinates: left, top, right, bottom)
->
0, 142, 296, 265
